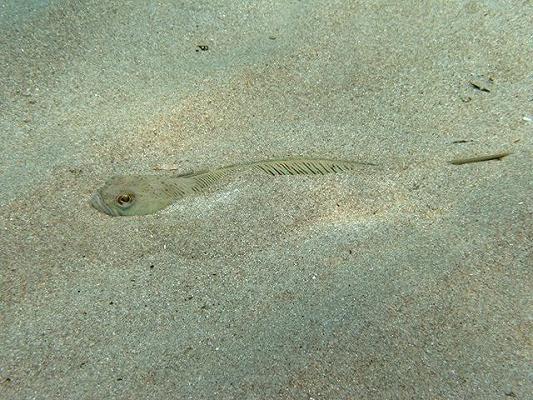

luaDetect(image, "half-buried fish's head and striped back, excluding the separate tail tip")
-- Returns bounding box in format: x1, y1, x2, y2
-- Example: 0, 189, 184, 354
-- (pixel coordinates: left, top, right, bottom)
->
91, 158, 374, 216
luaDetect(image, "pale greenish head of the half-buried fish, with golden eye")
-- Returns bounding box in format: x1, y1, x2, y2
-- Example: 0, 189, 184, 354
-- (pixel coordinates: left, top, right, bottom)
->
91, 175, 176, 217
